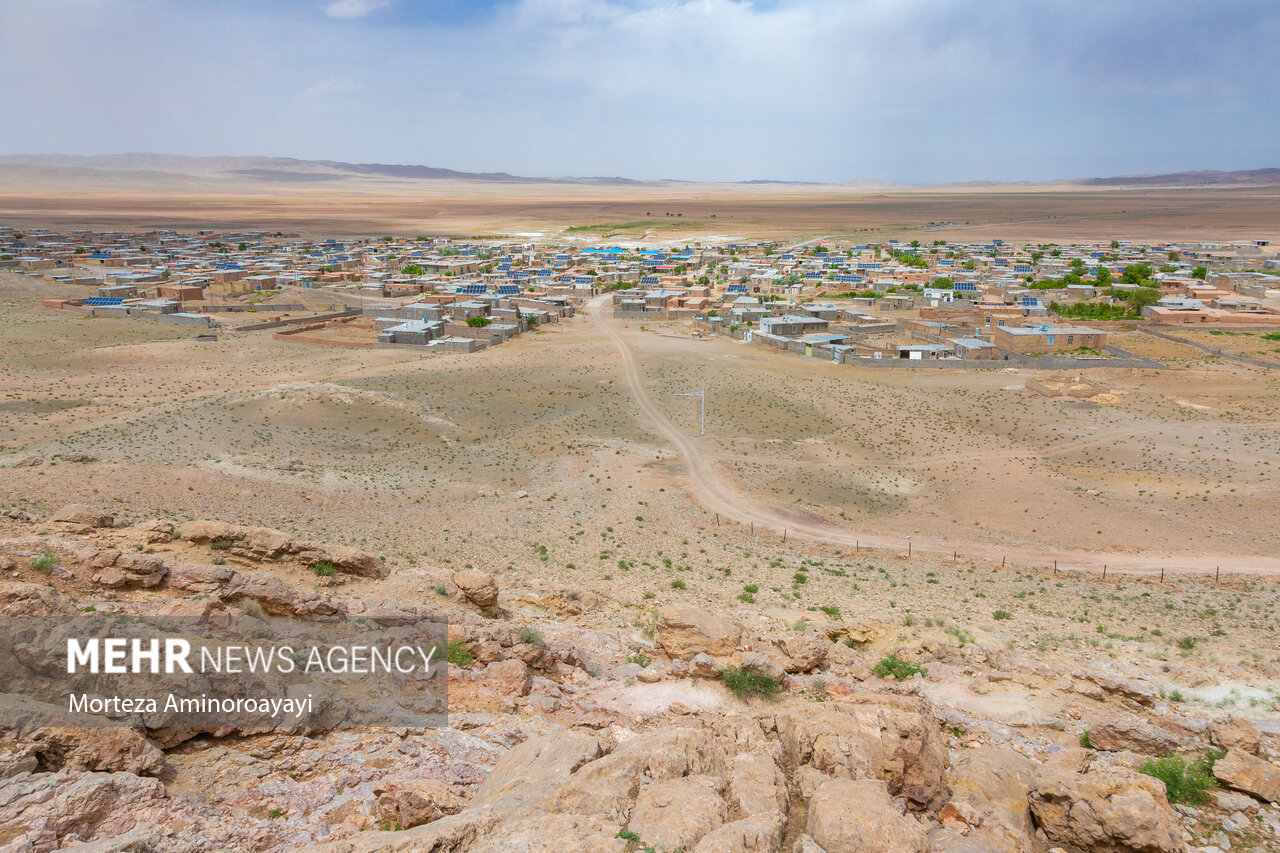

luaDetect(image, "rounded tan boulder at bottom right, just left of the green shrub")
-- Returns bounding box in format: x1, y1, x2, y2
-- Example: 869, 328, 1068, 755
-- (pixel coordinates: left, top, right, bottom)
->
1028, 765, 1185, 853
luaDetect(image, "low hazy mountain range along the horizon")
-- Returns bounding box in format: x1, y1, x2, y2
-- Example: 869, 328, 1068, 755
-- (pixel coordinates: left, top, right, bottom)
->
0, 154, 1280, 190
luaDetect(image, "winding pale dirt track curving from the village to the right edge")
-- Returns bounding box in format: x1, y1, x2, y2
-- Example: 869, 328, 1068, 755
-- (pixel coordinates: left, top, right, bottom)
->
589, 293, 1280, 574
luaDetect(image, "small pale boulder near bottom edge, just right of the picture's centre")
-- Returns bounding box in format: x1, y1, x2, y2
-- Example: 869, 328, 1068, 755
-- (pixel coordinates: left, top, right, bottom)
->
627, 776, 726, 850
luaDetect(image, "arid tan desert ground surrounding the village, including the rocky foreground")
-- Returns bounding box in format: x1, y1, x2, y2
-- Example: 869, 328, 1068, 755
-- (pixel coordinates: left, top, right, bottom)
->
0, 178, 1280, 853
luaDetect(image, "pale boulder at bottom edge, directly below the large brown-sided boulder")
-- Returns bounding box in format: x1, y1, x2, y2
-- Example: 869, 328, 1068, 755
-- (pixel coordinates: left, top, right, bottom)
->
805, 779, 929, 853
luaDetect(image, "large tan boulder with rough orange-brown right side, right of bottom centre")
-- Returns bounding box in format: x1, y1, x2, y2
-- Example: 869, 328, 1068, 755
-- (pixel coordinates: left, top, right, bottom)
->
776, 703, 947, 808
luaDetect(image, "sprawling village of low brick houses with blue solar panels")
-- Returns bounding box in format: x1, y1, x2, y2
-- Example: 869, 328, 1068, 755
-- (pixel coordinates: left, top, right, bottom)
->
0, 227, 1280, 369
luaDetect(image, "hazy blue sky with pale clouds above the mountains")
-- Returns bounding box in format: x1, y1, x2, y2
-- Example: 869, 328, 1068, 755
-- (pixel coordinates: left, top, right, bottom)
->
0, 0, 1280, 184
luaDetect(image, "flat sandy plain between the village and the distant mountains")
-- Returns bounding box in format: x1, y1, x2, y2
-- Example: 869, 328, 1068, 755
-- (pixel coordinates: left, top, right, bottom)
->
0, 174, 1280, 242
